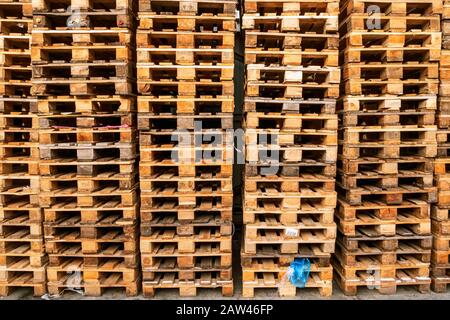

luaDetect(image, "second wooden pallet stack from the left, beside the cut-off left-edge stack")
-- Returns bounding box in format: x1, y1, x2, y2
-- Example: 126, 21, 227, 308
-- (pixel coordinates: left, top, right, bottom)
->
31, 0, 140, 296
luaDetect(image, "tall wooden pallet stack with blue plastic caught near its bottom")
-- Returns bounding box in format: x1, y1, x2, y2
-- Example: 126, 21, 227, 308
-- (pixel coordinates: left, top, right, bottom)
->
241, 0, 340, 297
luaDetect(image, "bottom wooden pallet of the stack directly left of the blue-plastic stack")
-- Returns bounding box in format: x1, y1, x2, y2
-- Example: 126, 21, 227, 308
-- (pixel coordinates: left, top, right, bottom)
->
142, 272, 233, 298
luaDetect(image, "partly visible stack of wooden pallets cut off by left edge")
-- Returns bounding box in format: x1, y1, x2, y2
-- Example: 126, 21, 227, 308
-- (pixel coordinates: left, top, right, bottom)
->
0, 1, 47, 296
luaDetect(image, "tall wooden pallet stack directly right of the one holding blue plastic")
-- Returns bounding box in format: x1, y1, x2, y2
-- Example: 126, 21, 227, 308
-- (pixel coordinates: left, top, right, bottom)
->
333, 0, 442, 295
